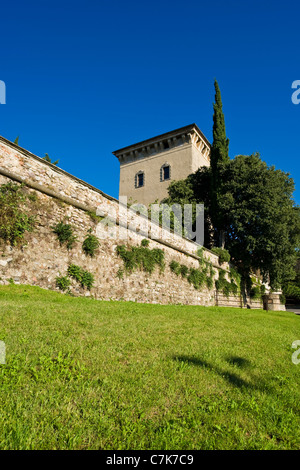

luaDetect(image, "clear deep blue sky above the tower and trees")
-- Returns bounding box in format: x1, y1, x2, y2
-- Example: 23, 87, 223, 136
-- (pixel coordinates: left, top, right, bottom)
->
0, 0, 300, 203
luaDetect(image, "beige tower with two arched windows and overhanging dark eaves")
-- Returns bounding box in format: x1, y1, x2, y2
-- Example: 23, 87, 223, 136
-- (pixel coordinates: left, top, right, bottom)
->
113, 124, 211, 206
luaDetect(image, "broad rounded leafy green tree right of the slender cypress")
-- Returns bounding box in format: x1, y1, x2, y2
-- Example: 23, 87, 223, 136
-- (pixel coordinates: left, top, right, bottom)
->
219, 154, 300, 289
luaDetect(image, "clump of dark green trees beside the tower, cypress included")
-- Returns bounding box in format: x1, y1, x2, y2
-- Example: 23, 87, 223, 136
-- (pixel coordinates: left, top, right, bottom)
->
164, 82, 300, 289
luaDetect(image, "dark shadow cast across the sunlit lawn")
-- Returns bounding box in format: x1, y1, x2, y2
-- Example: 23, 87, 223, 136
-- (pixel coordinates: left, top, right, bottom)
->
173, 355, 271, 392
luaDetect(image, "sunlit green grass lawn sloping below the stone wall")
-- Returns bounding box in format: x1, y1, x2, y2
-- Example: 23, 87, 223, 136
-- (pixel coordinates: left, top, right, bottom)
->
0, 285, 300, 450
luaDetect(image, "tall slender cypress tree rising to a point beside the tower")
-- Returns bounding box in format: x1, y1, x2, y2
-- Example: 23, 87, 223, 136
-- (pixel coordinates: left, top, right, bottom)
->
210, 80, 230, 247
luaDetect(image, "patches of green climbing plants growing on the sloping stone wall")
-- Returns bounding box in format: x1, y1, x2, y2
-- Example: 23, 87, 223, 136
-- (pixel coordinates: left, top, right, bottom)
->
0, 178, 244, 298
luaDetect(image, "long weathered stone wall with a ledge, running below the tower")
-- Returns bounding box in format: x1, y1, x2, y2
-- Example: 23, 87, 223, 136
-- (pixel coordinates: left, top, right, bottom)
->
0, 137, 262, 306
